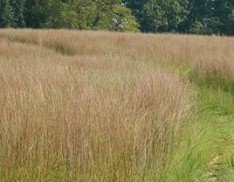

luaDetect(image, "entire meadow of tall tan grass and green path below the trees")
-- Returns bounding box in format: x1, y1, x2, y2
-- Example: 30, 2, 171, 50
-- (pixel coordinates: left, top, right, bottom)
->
0, 29, 234, 182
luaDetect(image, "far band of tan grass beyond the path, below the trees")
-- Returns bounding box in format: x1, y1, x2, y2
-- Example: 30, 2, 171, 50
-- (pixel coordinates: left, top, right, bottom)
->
0, 30, 234, 79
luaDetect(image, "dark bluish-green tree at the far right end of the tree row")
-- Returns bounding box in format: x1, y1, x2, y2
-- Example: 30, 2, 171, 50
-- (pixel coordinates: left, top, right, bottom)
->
186, 0, 233, 34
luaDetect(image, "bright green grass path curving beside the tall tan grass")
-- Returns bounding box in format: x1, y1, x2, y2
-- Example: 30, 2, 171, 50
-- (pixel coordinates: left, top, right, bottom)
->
0, 29, 234, 182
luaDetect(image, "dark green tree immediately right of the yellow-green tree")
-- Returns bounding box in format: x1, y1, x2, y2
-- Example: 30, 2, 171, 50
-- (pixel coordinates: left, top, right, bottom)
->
124, 0, 188, 32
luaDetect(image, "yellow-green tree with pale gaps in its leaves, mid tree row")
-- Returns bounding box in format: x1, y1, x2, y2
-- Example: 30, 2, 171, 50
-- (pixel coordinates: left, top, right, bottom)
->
75, 0, 138, 31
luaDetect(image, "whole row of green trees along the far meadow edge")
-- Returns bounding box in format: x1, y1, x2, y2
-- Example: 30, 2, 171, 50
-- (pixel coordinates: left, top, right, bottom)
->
0, 0, 234, 35
